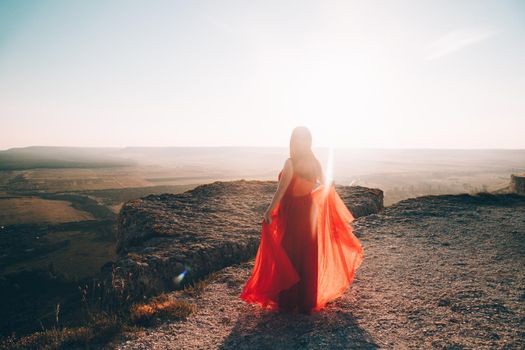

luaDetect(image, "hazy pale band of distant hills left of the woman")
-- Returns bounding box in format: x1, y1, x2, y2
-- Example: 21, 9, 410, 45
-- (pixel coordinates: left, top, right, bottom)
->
0, 146, 288, 174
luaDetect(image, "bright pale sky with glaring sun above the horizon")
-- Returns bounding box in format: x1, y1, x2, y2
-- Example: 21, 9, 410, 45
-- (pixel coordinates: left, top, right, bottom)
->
0, 0, 525, 149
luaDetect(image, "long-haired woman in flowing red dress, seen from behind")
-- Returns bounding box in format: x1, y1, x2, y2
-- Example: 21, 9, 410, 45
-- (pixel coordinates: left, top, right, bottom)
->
240, 127, 363, 314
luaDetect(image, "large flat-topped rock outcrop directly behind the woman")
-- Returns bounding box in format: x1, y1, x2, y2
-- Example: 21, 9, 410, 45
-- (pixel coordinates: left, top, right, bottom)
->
103, 180, 383, 302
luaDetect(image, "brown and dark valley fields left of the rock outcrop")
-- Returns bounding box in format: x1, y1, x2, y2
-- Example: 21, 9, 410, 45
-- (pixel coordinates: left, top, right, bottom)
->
0, 167, 201, 280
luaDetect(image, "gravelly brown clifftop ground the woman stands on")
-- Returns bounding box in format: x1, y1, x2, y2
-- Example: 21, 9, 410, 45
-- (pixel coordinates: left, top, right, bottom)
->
115, 195, 525, 350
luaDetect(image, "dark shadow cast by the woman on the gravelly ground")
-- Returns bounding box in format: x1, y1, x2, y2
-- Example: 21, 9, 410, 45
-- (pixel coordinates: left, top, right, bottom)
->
219, 305, 379, 350
